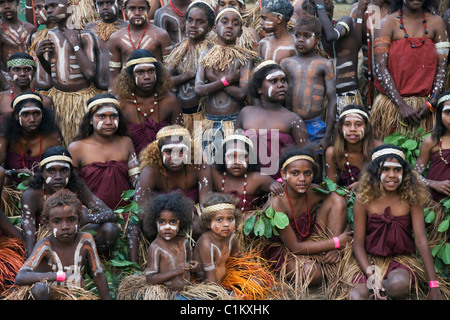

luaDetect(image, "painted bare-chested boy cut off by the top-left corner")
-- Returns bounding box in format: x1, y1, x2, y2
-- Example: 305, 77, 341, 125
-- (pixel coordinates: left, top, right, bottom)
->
0, 0, 36, 89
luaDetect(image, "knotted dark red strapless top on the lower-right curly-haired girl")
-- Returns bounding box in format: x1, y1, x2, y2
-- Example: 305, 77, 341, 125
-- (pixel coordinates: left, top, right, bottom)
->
365, 207, 415, 257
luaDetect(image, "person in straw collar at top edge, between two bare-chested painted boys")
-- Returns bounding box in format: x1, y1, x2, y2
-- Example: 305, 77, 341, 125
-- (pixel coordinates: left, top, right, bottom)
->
84, 0, 128, 91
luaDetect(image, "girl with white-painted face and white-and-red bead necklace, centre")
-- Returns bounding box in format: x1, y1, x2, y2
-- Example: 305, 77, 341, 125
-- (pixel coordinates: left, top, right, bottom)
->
199, 133, 280, 214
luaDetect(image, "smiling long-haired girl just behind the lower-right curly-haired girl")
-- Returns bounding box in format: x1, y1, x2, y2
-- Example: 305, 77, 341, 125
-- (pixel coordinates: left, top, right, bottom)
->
325, 105, 382, 190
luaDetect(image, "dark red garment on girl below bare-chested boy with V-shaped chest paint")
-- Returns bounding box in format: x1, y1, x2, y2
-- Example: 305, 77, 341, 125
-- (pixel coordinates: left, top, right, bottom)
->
128, 118, 170, 155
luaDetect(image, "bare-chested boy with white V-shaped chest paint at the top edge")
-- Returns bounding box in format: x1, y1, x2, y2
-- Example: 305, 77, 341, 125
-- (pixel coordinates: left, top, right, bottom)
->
109, 0, 172, 90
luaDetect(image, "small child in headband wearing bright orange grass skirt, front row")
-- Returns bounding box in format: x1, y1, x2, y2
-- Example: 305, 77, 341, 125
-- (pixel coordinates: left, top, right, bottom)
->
194, 193, 274, 300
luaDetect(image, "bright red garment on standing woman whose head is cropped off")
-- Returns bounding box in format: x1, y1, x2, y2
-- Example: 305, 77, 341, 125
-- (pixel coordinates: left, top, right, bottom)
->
374, 38, 437, 97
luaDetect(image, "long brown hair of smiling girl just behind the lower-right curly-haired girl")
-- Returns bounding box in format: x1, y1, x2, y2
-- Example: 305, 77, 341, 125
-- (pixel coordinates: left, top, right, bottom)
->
333, 105, 375, 170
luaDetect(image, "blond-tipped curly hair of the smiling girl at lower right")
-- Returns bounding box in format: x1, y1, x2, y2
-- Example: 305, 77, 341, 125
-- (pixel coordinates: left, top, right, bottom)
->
356, 144, 430, 206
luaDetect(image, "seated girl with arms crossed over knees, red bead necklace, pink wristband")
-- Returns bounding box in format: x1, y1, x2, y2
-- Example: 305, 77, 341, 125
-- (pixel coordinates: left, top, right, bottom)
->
267, 147, 352, 295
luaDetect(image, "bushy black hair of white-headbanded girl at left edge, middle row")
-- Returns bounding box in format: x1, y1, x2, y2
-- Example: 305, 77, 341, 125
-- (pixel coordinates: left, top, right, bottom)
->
0, 91, 61, 143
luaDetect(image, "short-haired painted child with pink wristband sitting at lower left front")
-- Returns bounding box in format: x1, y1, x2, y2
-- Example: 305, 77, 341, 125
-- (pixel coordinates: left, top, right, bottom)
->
12, 189, 110, 300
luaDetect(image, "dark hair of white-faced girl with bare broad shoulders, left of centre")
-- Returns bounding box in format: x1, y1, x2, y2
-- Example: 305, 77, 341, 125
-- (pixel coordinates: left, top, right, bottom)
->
73, 93, 128, 141
